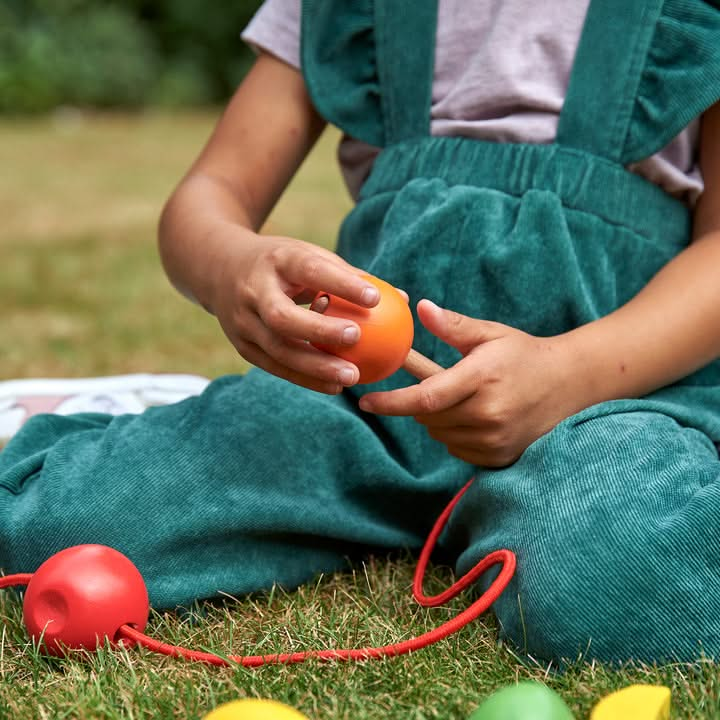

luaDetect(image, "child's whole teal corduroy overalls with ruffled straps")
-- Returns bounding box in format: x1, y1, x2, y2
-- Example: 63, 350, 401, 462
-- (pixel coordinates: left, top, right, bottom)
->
0, 0, 720, 660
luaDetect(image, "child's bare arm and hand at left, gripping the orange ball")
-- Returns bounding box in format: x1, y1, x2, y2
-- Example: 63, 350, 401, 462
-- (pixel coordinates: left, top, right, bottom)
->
159, 55, 378, 393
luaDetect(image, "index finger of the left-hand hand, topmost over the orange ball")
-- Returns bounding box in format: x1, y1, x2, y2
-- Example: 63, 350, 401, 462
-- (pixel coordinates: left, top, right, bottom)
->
278, 253, 380, 307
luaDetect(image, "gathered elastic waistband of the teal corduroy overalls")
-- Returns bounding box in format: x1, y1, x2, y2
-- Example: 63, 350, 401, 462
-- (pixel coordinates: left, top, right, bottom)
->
360, 137, 691, 243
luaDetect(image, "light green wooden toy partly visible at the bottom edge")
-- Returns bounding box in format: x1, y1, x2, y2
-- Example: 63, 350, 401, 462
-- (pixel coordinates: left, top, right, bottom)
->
469, 681, 573, 720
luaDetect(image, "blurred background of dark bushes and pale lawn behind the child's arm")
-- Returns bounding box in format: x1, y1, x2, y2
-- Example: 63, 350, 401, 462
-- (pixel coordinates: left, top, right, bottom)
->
0, 0, 351, 380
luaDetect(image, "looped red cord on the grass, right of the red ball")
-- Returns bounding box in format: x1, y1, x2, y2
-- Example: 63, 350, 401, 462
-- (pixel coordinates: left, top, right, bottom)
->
118, 480, 515, 667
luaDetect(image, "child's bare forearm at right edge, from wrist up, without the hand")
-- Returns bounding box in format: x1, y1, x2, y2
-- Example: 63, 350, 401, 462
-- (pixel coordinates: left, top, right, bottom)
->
558, 230, 720, 406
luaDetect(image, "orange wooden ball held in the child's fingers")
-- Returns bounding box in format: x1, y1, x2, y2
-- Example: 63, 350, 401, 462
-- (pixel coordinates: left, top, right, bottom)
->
315, 275, 414, 383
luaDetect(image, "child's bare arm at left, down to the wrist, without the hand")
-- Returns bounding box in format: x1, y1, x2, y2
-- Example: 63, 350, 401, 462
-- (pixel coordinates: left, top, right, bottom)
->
159, 55, 325, 311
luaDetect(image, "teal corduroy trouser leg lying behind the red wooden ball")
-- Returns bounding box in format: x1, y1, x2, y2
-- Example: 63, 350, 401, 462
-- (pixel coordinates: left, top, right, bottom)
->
0, 371, 465, 607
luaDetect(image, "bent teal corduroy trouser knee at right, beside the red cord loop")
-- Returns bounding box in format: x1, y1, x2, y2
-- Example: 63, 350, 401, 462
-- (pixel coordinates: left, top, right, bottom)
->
461, 404, 720, 660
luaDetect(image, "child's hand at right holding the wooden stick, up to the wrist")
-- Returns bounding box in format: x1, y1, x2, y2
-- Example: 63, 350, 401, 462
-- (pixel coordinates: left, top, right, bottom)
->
360, 300, 584, 467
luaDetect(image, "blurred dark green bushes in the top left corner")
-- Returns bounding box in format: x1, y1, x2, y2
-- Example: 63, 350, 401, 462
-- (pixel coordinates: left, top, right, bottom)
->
0, 0, 261, 114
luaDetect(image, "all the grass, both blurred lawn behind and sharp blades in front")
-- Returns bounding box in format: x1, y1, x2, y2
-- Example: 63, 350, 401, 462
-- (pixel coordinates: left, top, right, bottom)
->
0, 113, 720, 720
